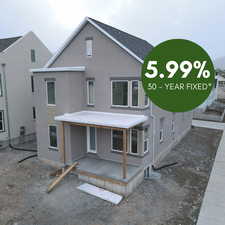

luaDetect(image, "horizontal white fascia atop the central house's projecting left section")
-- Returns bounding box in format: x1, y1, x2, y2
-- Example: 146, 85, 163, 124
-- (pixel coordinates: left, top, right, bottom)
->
30, 66, 85, 73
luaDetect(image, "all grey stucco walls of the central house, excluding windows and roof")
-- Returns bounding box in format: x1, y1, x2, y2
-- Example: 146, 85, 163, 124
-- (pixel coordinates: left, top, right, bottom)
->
33, 24, 192, 171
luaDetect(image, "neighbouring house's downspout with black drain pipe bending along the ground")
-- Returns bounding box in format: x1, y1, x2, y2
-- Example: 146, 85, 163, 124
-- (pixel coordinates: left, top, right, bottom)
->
2, 63, 37, 152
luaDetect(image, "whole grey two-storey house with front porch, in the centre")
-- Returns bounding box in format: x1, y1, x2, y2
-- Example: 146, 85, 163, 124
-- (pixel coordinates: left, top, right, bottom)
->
32, 18, 192, 195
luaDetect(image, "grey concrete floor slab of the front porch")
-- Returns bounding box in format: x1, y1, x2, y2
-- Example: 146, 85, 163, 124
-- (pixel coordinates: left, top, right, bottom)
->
78, 157, 141, 182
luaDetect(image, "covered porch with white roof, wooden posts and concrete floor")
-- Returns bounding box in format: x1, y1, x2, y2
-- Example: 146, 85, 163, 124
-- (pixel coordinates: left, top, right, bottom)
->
55, 111, 148, 181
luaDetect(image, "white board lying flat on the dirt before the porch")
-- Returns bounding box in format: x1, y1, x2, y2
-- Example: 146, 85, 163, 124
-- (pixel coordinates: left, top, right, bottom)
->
77, 183, 123, 205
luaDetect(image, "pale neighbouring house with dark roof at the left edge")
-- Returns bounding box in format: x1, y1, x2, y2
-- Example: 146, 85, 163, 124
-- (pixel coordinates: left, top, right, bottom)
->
0, 32, 52, 145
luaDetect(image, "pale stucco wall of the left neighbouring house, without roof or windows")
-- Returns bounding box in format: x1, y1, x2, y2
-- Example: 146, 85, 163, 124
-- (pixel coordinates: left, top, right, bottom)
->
0, 32, 51, 141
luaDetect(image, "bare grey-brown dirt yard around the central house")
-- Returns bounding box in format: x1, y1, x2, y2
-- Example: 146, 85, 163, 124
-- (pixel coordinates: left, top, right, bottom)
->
0, 128, 222, 225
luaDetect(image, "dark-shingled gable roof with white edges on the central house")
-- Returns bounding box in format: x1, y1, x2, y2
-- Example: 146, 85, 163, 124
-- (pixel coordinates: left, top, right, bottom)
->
45, 17, 153, 67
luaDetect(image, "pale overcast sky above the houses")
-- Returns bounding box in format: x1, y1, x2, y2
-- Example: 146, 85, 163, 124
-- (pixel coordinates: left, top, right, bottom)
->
0, 0, 225, 59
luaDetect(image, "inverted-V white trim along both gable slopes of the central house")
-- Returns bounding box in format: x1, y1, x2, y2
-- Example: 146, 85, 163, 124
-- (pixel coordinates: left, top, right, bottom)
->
44, 17, 144, 68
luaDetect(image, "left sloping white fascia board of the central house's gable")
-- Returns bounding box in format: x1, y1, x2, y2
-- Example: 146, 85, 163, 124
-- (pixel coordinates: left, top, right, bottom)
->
44, 17, 87, 68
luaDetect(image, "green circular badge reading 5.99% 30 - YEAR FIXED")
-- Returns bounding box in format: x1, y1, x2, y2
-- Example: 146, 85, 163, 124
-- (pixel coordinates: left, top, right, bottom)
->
142, 39, 215, 112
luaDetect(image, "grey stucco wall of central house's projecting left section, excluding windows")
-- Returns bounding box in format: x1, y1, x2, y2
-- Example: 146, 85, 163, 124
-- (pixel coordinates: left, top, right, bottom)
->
34, 72, 84, 162
